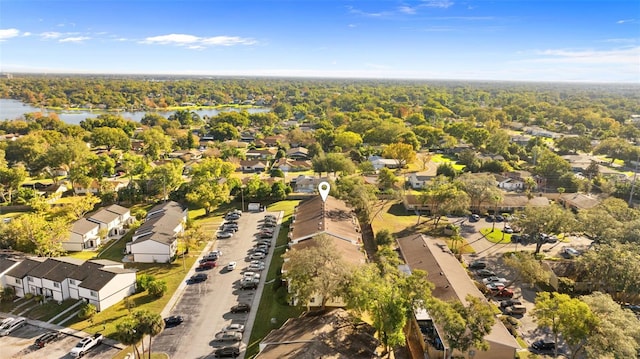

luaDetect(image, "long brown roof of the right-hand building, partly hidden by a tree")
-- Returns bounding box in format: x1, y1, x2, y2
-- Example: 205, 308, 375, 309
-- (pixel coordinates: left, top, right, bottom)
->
398, 234, 520, 350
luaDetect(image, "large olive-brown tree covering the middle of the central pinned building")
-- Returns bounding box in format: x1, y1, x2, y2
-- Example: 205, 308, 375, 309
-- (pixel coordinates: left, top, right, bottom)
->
283, 235, 352, 310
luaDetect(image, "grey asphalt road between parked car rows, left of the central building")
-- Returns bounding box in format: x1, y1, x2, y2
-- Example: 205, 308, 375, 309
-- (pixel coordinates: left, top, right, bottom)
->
152, 212, 277, 359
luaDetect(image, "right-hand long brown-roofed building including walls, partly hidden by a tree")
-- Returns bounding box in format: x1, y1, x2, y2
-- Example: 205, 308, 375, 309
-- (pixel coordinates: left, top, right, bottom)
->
398, 234, 520, 359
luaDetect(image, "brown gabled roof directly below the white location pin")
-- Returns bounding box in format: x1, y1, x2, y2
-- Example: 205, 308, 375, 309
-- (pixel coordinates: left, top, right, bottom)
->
289, 196, 361, 243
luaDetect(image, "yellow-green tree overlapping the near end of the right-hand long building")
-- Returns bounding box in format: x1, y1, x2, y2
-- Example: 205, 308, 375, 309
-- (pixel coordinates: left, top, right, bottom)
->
430, 294, 495, 355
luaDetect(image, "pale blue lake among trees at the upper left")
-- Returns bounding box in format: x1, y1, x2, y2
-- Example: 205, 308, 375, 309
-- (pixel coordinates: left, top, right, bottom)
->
0, 98, 271, 125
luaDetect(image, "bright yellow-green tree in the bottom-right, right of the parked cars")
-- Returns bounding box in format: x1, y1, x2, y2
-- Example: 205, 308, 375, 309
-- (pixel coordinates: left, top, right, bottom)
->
533, 292, 599, 359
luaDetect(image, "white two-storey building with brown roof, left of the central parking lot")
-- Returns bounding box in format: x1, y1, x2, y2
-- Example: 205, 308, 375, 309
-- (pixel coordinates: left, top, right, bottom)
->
127, 201, 187, 263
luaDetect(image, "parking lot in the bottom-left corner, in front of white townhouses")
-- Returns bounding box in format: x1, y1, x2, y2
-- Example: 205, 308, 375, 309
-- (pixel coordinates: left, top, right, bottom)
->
0, 324, 120, 359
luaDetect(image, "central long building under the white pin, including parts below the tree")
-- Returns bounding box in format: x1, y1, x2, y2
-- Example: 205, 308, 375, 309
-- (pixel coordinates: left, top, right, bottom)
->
282, 196, 366, 307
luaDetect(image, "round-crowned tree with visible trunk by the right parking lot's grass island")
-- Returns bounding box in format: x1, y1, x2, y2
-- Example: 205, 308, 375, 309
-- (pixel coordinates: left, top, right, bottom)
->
514, 204, 576, 254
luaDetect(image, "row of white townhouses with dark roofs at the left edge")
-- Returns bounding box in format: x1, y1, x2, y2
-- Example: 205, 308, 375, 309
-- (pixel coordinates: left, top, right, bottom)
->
5, 257, 136, 311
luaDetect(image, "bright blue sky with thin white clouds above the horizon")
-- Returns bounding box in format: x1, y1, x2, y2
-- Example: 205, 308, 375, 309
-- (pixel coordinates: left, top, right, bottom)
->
0, 0, 640, 83
